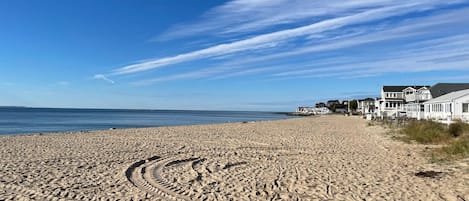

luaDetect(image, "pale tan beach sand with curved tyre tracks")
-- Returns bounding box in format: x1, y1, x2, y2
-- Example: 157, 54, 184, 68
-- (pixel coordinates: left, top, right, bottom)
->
0, 116, 469, 200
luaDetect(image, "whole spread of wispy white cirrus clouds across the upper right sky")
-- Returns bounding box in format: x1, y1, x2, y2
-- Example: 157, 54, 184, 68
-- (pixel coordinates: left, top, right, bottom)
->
95, 0, 469, 85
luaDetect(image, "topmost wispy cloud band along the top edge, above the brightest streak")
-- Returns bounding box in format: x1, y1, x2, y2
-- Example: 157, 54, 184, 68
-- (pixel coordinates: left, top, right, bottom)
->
156, 0, 461, 40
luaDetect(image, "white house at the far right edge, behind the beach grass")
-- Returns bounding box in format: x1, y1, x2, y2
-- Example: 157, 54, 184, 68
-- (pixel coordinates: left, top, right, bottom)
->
424, 89, 469, 122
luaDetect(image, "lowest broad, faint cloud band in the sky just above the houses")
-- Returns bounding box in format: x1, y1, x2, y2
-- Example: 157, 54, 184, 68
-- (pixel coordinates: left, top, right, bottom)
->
260, 31, 469, 80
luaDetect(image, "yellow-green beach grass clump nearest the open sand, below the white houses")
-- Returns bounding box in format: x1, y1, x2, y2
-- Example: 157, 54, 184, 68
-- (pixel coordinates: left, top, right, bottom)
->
401, 121, 451, 144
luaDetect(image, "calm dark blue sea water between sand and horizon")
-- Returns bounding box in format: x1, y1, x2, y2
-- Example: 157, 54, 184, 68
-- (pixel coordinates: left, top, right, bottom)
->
0, 108, 288, 135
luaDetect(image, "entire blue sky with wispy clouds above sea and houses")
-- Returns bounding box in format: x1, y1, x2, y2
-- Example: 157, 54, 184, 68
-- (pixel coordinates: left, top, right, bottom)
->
0, 0, 469, 111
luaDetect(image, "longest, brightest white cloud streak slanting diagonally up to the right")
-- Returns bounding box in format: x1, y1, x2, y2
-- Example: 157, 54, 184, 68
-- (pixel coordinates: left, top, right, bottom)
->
104, 2, 458, 75
